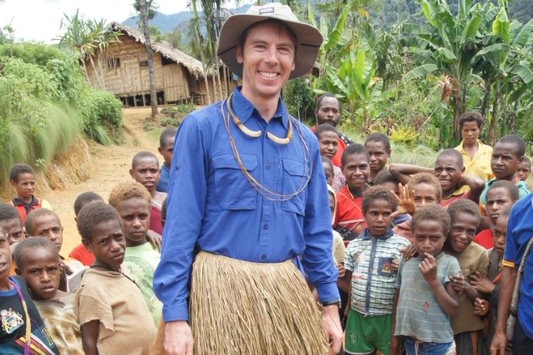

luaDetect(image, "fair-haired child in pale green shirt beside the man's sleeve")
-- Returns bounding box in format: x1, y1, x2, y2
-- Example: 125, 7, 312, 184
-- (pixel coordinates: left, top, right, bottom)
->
109, 181, 162, 326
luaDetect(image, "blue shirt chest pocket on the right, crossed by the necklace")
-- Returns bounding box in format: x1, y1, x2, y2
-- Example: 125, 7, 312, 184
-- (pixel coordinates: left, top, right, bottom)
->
281, 159, 310, 216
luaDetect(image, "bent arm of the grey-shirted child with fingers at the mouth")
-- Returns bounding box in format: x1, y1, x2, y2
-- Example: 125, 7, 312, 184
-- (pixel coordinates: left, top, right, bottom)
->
418, 253, 459, 317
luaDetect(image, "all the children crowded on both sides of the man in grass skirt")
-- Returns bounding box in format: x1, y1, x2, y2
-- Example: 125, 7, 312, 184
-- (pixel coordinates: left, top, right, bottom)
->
0, 107, 531, 355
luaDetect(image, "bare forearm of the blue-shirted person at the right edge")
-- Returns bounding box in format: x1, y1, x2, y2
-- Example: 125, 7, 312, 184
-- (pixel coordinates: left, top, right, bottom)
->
490, 265, 517, 355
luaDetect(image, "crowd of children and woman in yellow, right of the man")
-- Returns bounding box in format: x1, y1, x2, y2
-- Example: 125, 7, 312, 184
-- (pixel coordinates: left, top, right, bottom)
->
315, 113, 531, 355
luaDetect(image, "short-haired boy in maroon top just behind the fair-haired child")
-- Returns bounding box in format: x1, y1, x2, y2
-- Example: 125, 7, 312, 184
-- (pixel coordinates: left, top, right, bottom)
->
130, 152, 167, 235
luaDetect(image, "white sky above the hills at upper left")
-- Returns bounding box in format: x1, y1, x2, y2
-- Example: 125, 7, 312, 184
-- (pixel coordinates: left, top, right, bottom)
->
0, 0, 243, 43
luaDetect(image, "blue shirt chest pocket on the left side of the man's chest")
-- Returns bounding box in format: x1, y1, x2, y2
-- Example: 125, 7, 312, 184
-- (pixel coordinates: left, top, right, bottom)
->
212, 154, 257, 210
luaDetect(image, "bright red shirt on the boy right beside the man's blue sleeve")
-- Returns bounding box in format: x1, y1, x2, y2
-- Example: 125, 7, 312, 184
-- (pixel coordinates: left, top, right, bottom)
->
335, 186, 367, 234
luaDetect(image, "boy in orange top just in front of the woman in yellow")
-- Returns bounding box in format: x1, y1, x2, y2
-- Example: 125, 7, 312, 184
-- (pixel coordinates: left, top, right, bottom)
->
435, 149, 485, 207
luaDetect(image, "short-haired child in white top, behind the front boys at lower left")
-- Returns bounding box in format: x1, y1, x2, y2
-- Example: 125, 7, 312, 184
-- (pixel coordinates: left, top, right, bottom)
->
25, 208, 85, 292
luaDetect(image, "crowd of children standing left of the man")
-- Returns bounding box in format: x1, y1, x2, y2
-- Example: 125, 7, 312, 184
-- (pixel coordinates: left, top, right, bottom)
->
0, 128, 176, 354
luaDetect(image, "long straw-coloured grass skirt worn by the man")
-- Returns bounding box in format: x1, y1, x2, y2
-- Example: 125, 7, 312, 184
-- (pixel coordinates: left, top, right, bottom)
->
190, 252, 330, 355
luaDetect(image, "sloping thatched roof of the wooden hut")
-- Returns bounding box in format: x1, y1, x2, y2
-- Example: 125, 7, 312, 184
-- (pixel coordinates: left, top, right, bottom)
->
109, 22, 203, 76
